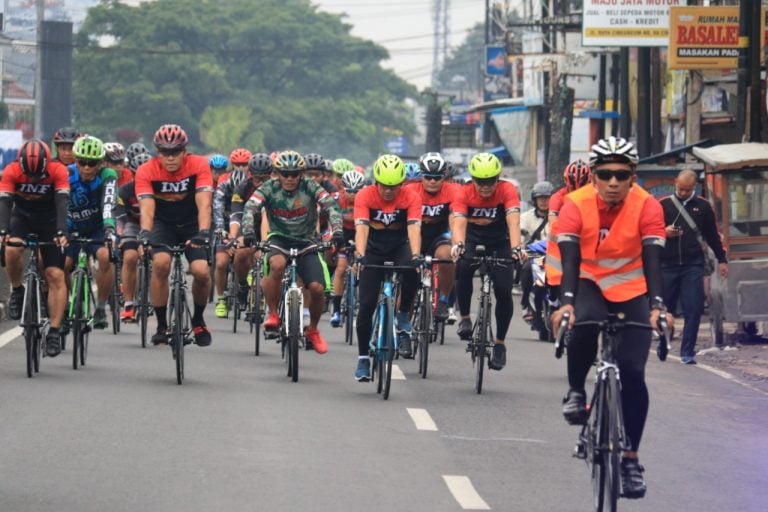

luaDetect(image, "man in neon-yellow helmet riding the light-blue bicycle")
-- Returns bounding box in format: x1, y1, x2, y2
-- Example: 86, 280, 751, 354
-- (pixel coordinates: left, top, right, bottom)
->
354, 155, 421, 382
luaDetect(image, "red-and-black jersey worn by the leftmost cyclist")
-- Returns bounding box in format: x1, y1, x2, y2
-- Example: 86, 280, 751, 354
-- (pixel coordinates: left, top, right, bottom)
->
0, 162, 69, 231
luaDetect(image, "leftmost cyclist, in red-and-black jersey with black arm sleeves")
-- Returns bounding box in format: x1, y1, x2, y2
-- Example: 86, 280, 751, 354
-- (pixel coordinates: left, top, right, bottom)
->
0, 140, 69, 357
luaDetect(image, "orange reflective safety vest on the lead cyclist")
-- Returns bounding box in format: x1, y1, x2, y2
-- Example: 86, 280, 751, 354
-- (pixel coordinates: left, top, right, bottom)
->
568, 184, 650, 302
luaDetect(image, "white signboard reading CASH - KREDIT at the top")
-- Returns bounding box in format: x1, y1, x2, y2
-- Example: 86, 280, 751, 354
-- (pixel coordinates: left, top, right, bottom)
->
581, 0, 688, 47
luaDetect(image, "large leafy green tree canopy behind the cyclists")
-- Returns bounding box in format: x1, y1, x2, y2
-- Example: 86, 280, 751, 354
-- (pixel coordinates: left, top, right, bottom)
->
73, 0, 416, 160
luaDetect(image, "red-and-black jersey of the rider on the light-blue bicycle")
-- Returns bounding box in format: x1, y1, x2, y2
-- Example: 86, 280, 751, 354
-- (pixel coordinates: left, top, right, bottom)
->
354, 185, 421, 254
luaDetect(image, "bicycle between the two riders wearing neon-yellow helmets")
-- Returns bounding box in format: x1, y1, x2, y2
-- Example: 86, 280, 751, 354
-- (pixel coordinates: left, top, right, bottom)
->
411, 256, 453, 379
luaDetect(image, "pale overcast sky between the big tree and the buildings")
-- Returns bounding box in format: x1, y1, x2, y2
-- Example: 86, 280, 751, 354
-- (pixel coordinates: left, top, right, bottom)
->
314, 0, 485, 89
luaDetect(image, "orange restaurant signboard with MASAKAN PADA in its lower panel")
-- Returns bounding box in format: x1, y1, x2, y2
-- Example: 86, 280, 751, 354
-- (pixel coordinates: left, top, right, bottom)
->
668, 6, 766, 69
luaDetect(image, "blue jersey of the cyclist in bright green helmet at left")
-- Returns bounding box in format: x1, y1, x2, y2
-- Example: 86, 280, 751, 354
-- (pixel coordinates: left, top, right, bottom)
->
67, 164, 117, 234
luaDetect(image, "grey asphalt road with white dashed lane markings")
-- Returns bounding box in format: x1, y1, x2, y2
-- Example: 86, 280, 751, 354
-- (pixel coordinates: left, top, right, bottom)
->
0, 300, 768, 512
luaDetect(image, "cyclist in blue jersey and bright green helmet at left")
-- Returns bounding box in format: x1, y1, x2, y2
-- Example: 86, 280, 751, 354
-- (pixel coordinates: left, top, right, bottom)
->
65, 135, 117, 329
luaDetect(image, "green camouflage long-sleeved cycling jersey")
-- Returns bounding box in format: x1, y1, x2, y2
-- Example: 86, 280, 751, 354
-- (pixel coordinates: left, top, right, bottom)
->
242, 178, 341, 241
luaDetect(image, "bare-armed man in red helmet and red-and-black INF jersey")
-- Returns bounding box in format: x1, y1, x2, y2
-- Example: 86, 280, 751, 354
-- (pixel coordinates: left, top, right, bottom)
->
136, 124, 213, 347
